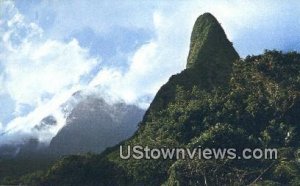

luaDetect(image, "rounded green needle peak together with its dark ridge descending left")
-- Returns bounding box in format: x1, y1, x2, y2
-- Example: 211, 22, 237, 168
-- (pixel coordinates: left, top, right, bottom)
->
144, 13, 239, 117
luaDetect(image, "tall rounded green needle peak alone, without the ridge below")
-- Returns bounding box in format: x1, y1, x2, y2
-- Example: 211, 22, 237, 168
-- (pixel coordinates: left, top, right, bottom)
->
187, 13, 239, 81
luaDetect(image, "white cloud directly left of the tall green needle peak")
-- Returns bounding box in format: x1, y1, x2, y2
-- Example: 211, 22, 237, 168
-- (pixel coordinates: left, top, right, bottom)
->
90, 11, 189, 108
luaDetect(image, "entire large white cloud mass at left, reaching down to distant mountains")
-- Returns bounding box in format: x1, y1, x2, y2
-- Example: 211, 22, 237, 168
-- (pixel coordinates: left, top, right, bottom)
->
0, 1, 100, 143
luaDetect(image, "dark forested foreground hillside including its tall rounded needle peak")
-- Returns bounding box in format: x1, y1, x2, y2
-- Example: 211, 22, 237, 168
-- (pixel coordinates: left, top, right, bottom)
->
7, 13, 300, 185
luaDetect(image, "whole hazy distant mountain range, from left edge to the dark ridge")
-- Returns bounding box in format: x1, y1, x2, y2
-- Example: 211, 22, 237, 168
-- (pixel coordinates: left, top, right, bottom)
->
0, 92, 145, 184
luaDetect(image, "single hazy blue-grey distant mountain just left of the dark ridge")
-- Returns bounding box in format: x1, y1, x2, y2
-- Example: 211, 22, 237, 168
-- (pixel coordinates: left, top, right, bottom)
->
49, 96, 144, 154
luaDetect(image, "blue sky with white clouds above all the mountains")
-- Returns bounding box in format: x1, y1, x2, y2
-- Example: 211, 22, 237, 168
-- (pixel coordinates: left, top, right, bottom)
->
0, 0, 300, 145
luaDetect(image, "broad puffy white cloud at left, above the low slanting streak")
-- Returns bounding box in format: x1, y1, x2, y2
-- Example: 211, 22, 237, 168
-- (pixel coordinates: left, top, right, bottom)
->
4, 40, 97, 105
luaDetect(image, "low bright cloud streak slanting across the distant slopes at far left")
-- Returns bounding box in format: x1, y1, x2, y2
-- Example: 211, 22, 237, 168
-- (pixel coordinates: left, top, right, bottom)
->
0, 87, 80, 145
